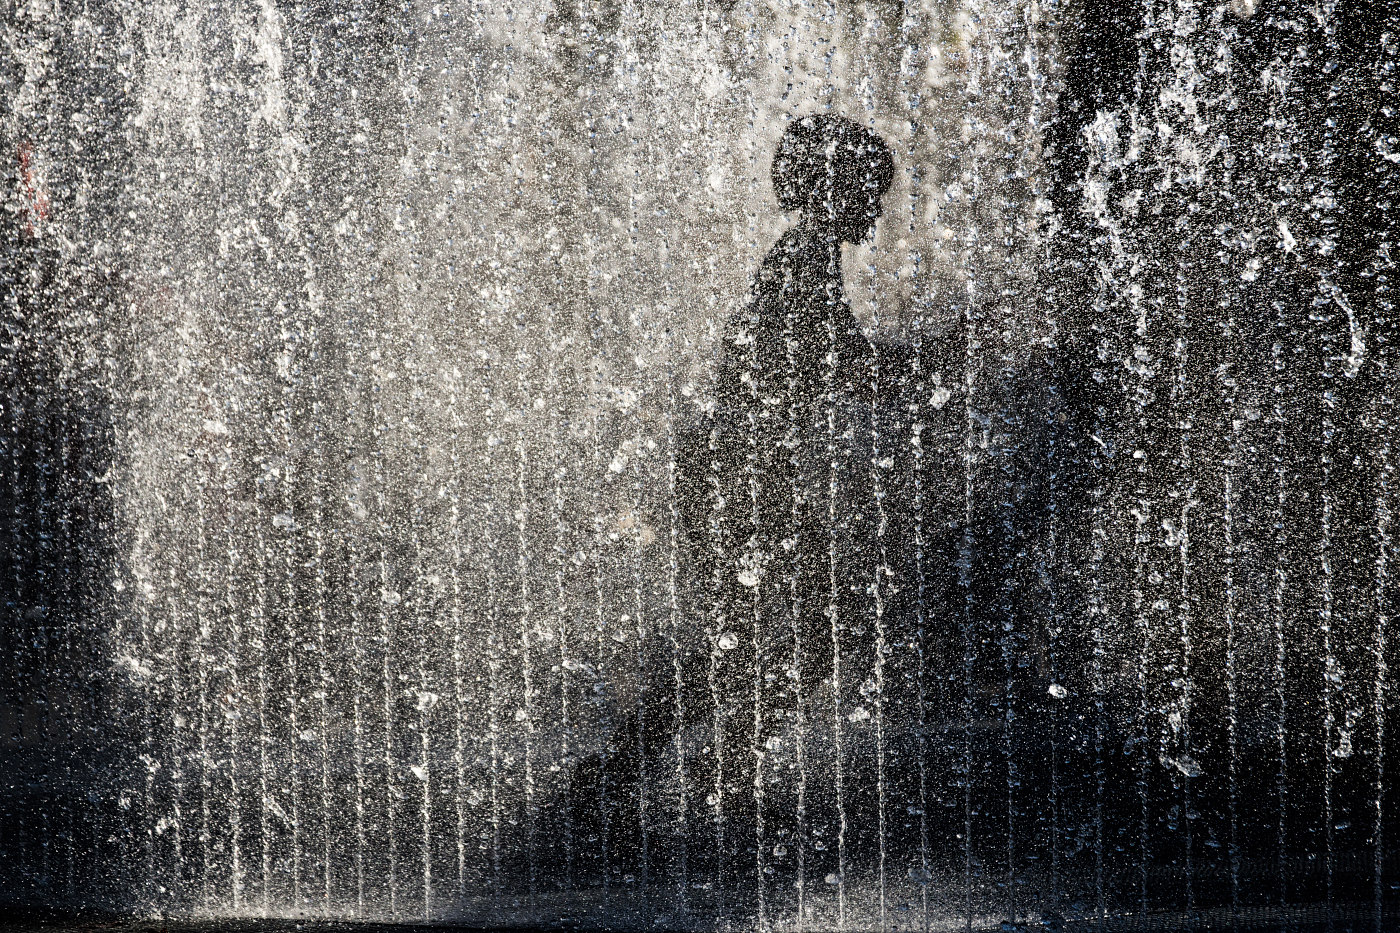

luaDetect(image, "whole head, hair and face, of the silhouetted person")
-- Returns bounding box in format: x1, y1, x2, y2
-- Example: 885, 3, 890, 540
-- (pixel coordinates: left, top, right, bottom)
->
773, 113, 895, 242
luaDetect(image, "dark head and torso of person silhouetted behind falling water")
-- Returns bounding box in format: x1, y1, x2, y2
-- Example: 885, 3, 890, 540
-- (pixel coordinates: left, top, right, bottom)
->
680, 115, 904, 691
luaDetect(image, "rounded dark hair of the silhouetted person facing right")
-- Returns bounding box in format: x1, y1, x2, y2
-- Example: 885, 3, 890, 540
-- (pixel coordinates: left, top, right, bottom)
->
773, 113, 895, 210
